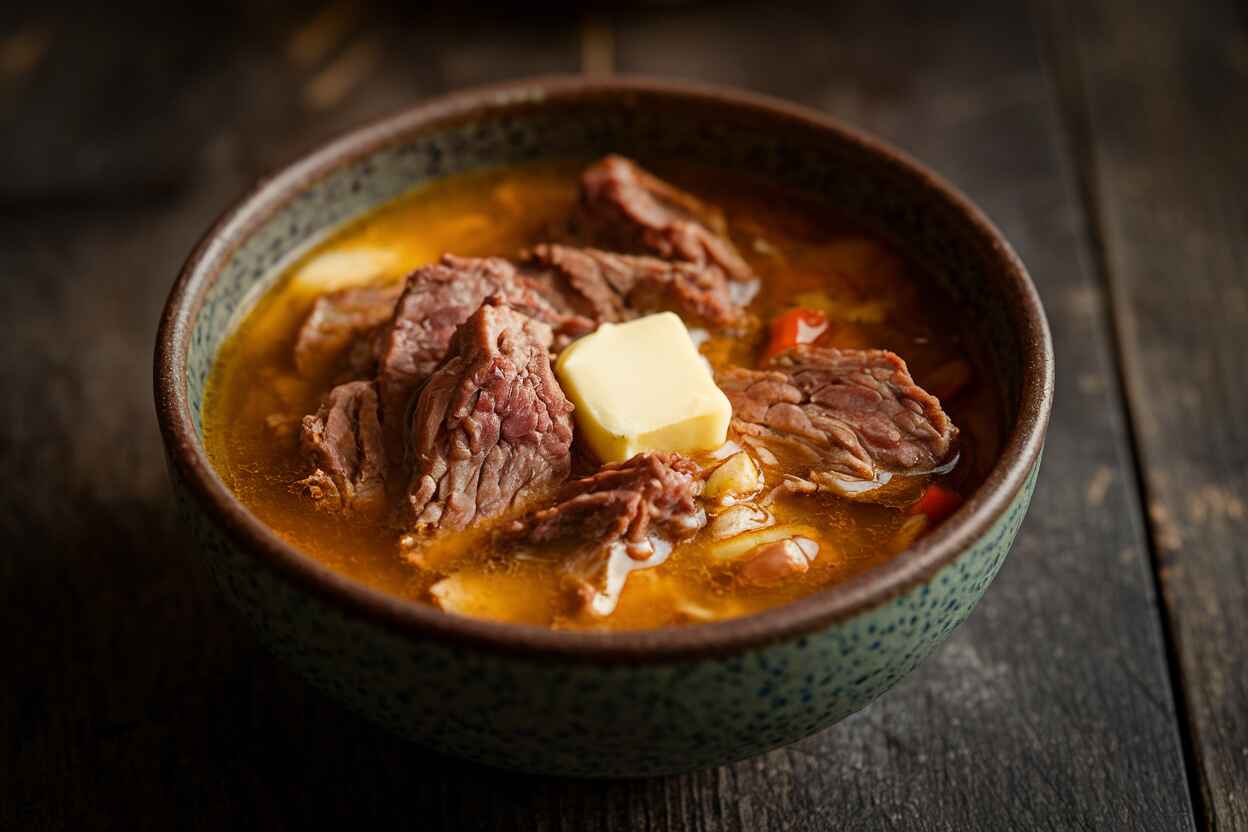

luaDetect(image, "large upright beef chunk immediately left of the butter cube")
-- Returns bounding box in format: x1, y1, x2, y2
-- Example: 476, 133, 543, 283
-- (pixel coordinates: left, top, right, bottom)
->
407, 294, 572, 530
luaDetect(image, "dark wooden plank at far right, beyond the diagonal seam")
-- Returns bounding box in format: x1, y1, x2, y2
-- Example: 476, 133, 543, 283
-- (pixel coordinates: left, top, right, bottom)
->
1055, 0, 1248, 830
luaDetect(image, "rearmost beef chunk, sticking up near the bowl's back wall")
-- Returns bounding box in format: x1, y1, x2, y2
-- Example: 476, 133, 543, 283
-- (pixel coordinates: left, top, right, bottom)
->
574, 155, 754, 281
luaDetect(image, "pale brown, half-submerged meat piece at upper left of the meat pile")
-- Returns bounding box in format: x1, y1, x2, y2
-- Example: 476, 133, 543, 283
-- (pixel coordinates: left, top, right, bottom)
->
295, 286, 403, 378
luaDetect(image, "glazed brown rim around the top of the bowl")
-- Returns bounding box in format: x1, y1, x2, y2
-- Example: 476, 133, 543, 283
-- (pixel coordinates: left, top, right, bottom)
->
155, 76, 1053, 664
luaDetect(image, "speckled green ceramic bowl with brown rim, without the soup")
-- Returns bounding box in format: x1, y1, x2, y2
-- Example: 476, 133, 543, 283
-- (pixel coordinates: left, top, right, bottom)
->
156, 79, 1053, 776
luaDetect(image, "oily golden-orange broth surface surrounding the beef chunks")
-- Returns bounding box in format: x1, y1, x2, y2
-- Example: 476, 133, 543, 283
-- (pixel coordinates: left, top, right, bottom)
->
203, 162, 1002, 630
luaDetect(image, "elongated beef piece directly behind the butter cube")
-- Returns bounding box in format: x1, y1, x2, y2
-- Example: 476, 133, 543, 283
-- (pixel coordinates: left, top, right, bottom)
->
523, 243, 741, 327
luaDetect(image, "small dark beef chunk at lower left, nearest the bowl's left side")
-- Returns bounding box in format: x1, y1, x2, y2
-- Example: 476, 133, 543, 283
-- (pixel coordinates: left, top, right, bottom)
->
292, 382, 386, 516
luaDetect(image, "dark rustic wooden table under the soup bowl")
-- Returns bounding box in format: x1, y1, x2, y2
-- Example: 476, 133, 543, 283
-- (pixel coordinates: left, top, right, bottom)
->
0, 0, 1248, 831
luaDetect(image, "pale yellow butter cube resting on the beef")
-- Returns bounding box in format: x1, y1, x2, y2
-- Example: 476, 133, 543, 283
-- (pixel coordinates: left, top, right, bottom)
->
555, 312, 733, 463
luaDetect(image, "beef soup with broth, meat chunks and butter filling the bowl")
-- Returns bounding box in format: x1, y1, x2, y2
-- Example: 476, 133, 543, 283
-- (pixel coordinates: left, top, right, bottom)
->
203, 157, 1002, 630
